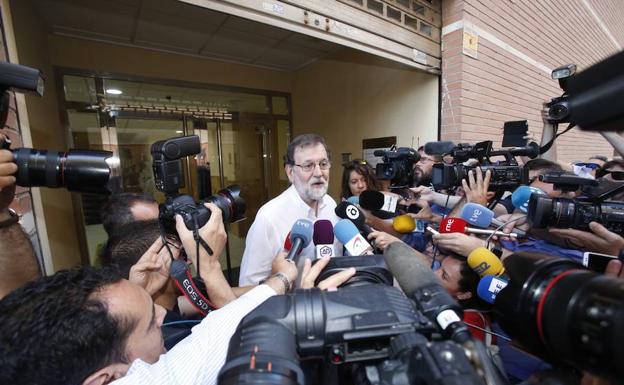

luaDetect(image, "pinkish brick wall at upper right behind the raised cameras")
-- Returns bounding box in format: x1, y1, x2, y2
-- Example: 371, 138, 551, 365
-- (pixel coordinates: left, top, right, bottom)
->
442, 0, 624, 162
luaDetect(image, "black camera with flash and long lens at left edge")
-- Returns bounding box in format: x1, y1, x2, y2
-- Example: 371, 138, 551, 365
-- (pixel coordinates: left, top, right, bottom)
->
0, 62, 115, 194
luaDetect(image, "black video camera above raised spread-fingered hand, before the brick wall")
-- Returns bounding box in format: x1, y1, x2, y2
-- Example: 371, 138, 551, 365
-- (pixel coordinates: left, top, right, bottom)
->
425, 140, 539, 191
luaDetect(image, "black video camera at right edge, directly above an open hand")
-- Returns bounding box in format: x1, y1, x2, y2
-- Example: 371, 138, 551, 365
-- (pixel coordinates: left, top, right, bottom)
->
527, 172, 624, 236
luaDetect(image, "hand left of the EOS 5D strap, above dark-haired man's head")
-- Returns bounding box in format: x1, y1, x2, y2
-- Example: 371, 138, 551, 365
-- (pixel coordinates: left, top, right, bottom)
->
128, 237, 174, 295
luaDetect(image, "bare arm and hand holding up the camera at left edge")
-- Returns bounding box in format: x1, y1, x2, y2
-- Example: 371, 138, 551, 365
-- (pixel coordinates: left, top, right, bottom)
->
0, 140, 40, 298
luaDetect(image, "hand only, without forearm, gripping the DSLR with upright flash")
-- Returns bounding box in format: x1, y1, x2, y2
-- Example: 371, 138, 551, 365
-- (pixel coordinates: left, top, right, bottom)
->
176, 203, 227, 273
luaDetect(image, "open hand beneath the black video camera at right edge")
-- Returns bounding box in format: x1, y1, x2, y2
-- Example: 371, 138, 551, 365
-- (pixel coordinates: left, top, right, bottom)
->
548, 222, 624, 255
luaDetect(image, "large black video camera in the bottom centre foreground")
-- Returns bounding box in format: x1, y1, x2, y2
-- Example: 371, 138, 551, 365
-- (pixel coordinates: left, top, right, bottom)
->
218, 284, 481, 385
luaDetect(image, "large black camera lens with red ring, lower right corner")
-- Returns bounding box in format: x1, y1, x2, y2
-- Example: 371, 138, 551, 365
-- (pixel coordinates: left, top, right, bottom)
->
493, 253, 624, 381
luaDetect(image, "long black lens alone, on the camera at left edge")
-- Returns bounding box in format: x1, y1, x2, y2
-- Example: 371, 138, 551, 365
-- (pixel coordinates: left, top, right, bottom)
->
13, 148, 113, 193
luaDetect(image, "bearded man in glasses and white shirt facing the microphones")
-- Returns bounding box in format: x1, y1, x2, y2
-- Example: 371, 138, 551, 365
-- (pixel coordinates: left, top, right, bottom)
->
239, 134, 342, 286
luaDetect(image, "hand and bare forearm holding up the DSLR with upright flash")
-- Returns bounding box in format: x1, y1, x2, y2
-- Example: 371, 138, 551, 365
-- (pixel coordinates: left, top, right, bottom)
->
175, 203, 236, 307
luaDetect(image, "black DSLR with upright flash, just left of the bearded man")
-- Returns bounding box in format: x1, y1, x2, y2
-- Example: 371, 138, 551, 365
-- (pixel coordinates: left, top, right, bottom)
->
151, 135, 245, 234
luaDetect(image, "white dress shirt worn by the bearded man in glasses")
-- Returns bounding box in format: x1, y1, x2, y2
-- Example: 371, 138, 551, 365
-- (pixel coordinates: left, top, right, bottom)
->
238, 185, 342, 286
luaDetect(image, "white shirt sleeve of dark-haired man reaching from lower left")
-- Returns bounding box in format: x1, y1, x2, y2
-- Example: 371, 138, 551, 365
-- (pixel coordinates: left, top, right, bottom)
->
113, 285, 275, 385
